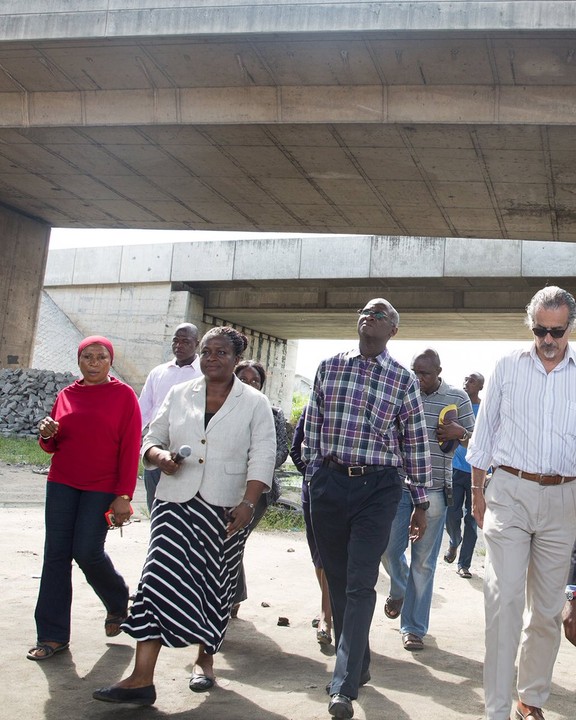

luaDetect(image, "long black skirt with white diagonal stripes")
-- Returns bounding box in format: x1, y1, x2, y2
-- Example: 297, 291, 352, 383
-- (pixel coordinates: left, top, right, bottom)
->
122, 496, 247, 654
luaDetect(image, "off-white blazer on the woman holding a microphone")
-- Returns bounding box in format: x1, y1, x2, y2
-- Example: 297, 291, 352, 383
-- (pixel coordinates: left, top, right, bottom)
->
142, 376, 276, 507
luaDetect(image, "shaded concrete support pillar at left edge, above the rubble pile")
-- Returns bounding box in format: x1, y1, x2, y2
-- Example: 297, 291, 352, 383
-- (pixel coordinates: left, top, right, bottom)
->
0, 208, 50, 368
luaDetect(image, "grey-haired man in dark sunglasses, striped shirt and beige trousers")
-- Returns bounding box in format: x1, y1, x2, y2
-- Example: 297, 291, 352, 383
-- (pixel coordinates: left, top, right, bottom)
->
466, 287, 576, 720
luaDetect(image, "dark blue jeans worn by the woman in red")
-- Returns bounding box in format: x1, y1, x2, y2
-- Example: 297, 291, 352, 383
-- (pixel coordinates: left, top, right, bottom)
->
34, 482, 128, 643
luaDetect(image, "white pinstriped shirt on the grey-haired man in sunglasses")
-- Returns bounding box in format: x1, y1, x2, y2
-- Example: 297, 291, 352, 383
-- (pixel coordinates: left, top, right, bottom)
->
466, 345, 576, 476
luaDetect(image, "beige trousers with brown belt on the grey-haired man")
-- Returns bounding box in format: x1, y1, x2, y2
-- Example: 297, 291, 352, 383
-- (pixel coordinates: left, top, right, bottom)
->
484, 468, 576, 720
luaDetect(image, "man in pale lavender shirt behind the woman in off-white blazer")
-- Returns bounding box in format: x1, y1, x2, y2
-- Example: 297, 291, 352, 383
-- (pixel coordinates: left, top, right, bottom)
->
138, 323, 202, 512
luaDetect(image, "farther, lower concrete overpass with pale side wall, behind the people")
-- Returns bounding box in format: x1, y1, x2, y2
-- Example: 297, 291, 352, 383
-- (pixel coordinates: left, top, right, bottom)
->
45, 236, 576, 396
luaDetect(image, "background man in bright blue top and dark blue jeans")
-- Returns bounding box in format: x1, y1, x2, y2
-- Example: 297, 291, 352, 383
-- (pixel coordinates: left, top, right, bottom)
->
444, 373, 484, 579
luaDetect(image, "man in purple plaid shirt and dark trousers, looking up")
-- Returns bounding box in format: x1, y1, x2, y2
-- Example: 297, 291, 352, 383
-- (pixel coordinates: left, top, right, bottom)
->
302, 298, 431, 719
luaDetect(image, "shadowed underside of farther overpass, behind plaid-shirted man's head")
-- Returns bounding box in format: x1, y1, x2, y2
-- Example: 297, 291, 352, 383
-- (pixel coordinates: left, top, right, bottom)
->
191, 278, 544, 340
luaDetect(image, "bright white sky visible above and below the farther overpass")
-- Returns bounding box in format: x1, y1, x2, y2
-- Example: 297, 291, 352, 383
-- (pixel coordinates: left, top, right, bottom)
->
50, 228, 528, 387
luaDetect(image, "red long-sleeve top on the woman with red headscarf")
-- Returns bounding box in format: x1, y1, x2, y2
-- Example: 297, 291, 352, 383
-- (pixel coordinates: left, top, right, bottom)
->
40, 378, 142, 497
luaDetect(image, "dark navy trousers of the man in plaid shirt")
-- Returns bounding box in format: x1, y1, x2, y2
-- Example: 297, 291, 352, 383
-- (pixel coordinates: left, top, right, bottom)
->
310, 466, 402, 699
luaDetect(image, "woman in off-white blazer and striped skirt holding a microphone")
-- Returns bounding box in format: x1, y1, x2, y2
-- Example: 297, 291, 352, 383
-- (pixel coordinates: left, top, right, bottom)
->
93, 326, 276, 705
